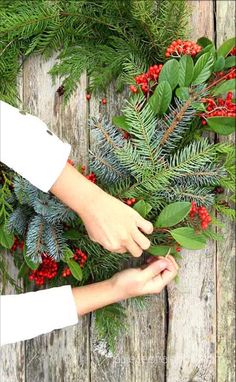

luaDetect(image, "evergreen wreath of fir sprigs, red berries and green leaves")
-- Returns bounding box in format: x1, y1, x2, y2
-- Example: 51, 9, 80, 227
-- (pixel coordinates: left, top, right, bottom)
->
0, 0, 236, 351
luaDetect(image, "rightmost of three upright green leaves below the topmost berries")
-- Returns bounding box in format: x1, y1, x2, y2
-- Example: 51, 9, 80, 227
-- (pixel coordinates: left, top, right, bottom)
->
192, 53, 214, 85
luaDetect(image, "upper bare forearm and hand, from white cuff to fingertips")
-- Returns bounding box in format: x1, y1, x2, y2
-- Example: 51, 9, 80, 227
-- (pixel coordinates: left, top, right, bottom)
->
50, 163, 153, 257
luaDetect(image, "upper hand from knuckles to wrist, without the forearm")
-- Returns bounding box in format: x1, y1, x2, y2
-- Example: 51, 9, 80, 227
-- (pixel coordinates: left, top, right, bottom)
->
80, 188, 153, 257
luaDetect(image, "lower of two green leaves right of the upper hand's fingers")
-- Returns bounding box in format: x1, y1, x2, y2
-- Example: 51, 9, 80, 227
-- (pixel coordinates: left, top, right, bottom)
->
170, 227, 206, 249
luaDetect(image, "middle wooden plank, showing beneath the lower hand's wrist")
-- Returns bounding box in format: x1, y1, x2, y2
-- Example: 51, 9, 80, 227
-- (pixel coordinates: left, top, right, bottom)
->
90, 86, 166, 382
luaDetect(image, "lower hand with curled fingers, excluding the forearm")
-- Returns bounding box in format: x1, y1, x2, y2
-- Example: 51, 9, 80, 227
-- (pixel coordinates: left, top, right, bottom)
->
110, 255, 179, 299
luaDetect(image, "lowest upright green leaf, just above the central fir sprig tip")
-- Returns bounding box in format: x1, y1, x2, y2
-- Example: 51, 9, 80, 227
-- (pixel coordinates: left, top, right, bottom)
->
148, 81, 172, 115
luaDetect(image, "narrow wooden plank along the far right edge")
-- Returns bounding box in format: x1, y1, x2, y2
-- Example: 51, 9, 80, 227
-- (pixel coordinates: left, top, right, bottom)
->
216, 1, 236, 382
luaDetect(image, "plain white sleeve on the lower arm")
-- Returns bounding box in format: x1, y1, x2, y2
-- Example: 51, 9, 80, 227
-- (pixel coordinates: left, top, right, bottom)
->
0, 285, 78, 345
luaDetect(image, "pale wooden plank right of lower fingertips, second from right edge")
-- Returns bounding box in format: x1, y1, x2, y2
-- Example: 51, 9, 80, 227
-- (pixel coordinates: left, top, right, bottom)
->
166, 1, 216, 382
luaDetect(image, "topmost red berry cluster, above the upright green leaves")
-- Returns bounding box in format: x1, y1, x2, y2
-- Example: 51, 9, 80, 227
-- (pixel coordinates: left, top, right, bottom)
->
166, 39, 202, 57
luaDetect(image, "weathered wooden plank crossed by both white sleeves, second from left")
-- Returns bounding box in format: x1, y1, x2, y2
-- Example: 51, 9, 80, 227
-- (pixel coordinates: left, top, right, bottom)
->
23, 56, 90, 382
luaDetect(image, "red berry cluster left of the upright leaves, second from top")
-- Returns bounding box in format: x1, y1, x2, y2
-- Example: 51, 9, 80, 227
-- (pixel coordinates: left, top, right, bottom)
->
130, 64, 163, 94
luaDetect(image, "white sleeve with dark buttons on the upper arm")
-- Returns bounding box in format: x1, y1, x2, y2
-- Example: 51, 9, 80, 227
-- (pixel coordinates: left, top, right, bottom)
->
0, 101, 71, 192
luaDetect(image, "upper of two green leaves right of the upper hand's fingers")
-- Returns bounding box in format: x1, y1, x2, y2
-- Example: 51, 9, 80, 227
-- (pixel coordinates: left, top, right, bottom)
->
155, 202, 191, 227
